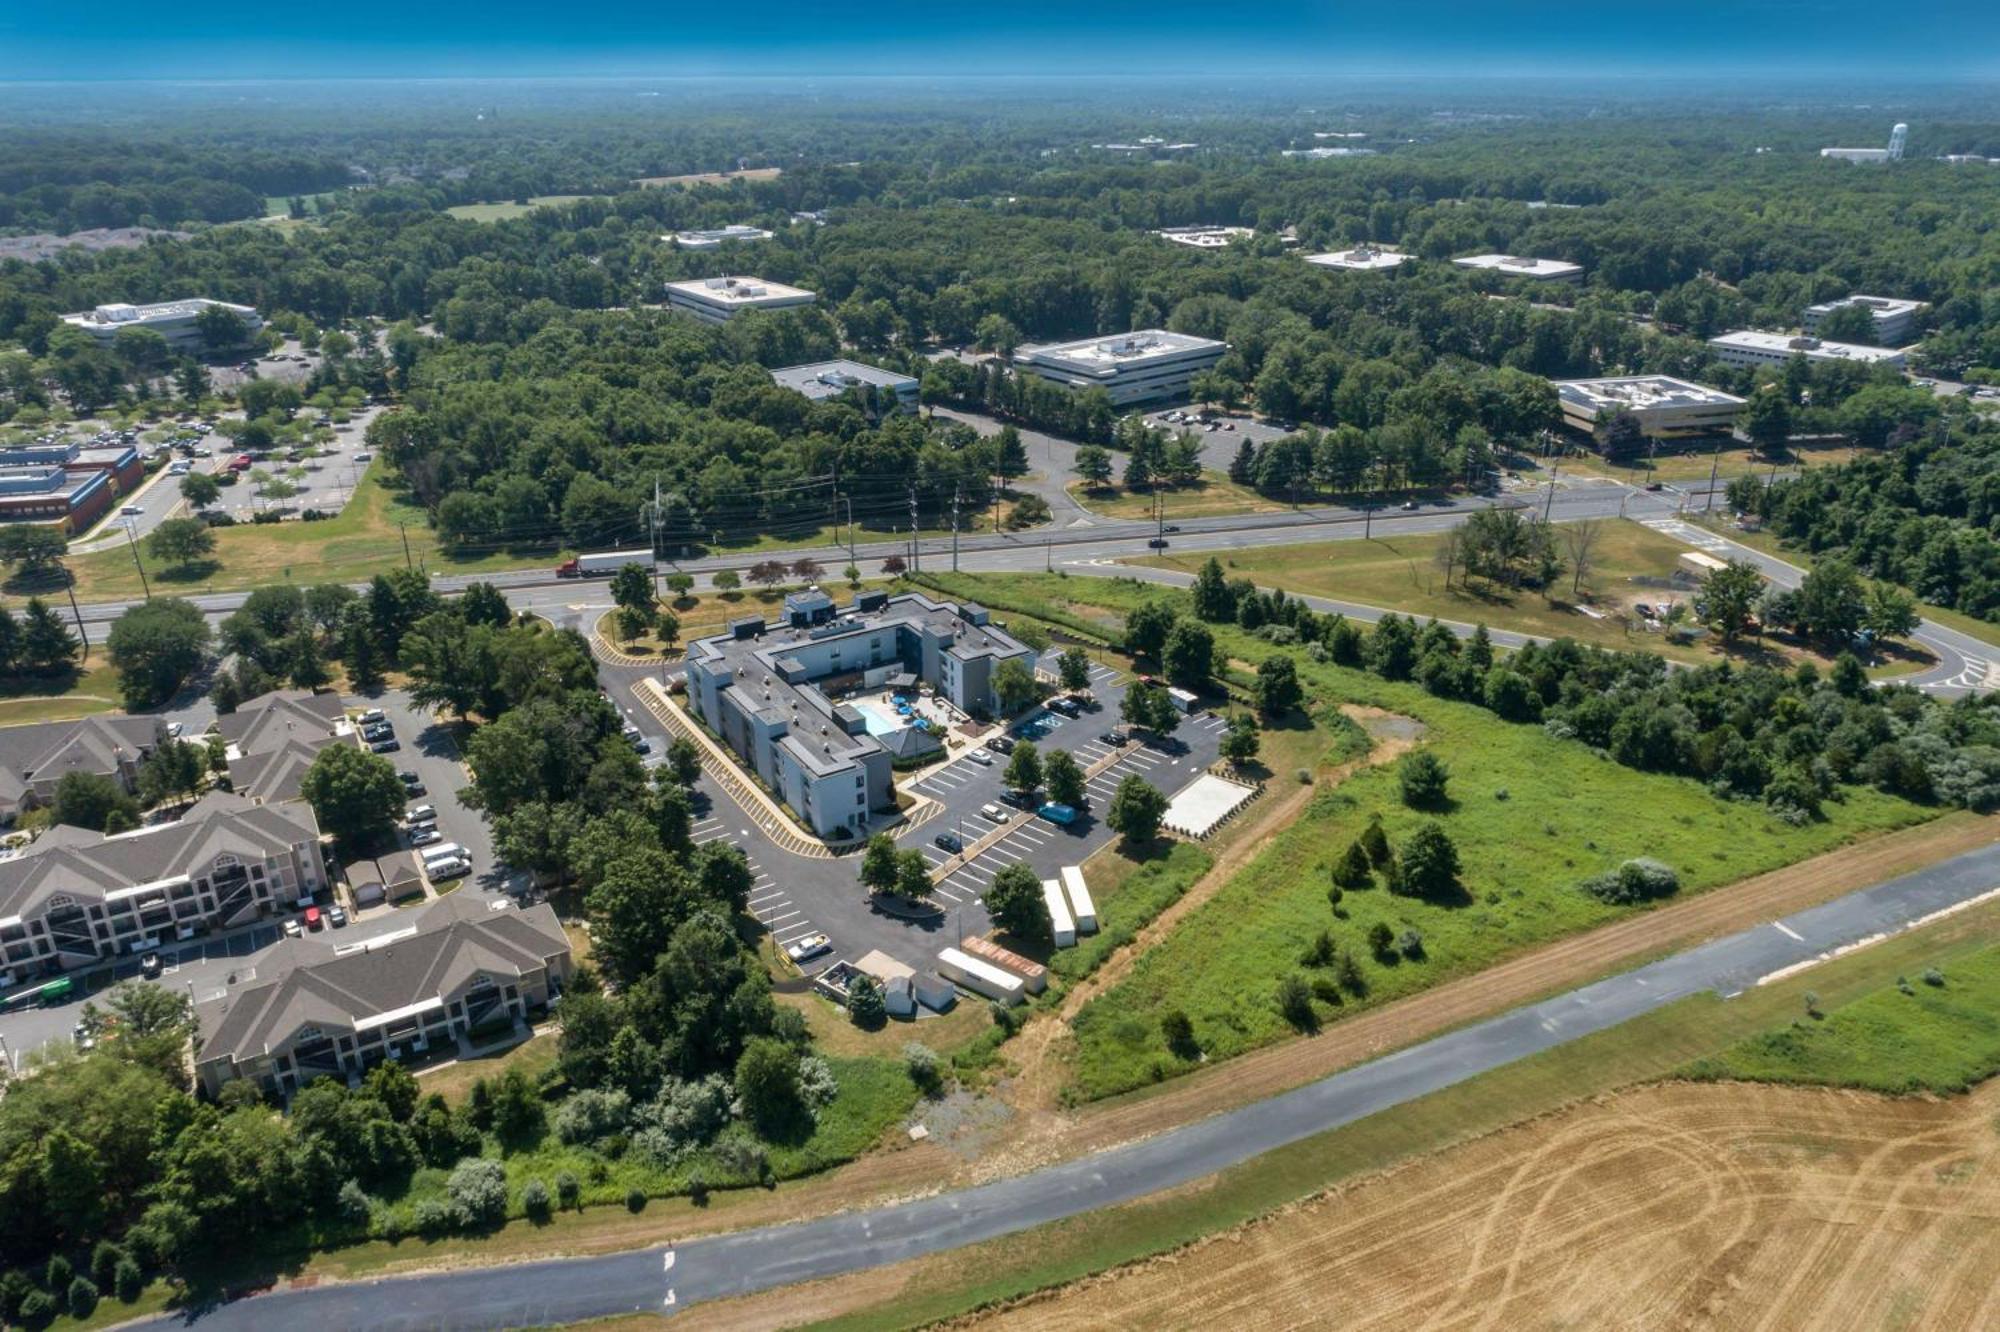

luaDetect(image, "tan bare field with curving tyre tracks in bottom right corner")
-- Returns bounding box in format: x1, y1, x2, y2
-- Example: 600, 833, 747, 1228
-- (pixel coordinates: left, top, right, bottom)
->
974, 1084, 2000, 1330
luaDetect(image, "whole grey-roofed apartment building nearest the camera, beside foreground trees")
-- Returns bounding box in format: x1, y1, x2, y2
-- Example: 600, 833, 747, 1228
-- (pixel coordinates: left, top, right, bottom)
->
194, 892, 570, 1096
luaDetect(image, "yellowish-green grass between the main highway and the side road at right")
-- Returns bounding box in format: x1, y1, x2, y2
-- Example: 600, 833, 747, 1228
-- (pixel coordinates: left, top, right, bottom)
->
1132, 518, 1932, 674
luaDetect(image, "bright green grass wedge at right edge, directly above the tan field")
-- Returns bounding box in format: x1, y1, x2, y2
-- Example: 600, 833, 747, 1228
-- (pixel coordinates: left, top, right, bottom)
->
1686, 932, 2000, 1094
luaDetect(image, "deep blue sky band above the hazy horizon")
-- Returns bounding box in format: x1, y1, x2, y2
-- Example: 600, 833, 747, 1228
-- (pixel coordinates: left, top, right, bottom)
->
0, 0, 2000, 82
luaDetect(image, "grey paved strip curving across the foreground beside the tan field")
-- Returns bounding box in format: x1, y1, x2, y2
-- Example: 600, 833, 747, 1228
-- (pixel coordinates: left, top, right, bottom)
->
142, 832, 2000, 1332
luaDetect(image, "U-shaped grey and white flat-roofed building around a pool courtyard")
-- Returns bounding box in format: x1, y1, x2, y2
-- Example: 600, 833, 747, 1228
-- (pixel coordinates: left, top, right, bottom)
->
686, 590, 1034, 838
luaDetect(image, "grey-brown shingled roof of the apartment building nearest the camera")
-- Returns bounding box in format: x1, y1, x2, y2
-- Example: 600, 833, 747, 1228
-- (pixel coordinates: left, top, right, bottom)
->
196, 892, 570, 1064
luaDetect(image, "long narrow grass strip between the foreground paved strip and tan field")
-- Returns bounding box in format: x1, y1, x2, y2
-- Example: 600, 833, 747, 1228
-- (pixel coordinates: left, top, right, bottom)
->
800, 888, 2000, 1332
